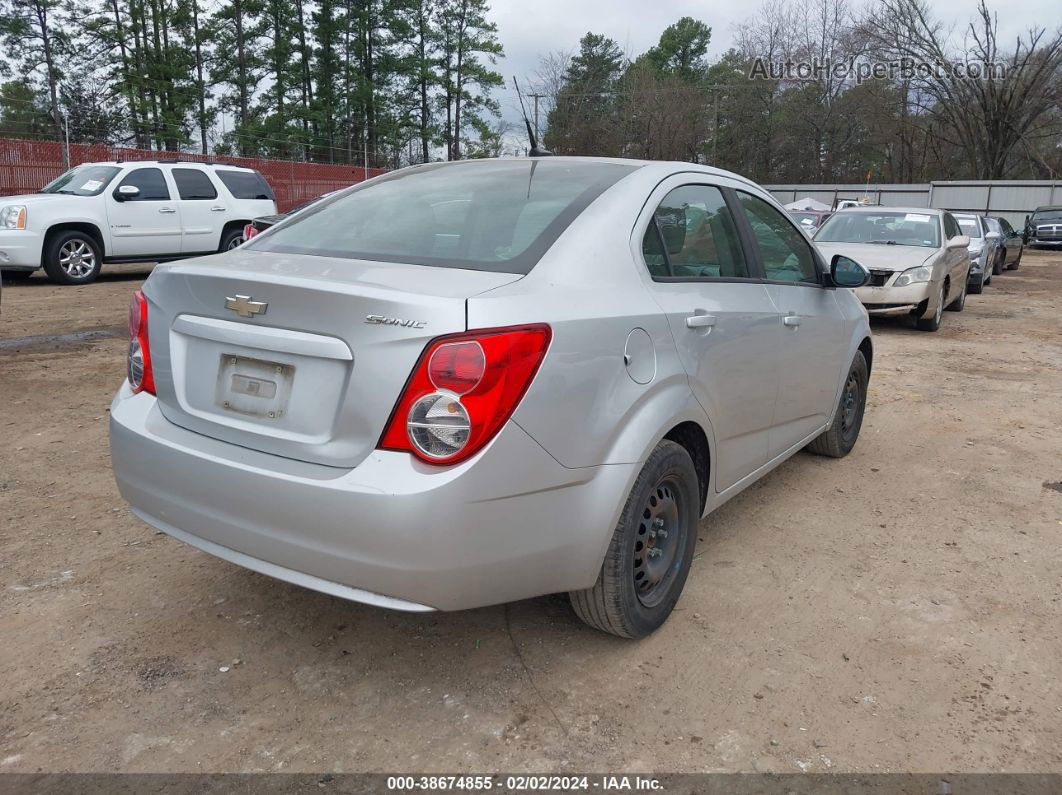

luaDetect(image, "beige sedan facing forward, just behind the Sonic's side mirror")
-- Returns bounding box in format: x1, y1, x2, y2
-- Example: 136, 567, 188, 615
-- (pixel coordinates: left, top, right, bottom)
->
815, 207, 970, 331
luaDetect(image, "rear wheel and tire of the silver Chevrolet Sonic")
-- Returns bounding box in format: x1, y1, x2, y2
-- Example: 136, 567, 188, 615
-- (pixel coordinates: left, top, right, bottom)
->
568, 439, 701, 638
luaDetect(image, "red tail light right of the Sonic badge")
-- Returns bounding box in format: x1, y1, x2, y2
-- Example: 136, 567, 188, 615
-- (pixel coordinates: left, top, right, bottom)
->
379, 325, 552, 464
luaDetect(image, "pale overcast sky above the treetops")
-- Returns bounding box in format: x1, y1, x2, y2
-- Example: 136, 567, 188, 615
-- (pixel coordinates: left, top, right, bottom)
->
491, 0, 1062, 139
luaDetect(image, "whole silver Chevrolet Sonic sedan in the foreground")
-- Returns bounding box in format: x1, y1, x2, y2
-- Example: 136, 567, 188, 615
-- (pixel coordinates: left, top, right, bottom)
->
110, 157, 872, 637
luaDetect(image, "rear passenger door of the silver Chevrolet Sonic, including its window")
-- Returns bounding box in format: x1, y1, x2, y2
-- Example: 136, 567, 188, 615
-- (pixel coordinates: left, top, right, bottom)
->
639, 174, 781, 491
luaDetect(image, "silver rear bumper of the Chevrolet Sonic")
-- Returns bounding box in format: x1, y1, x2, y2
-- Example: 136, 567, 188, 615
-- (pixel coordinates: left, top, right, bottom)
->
110, 385, 638, 610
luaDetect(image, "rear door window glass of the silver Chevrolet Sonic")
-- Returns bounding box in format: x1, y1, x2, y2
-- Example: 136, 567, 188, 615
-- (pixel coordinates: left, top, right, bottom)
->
643, 185, 749, 279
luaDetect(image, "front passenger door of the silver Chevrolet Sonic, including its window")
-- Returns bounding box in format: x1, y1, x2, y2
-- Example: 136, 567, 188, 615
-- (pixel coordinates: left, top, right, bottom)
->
737, 191, 847, 459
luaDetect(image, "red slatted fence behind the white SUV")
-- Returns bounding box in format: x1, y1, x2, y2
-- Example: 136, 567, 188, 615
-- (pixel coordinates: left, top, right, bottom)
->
0, 138, 386, 212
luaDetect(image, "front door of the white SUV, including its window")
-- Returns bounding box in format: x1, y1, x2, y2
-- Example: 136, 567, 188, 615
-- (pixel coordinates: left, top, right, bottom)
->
107, 166, 181, 257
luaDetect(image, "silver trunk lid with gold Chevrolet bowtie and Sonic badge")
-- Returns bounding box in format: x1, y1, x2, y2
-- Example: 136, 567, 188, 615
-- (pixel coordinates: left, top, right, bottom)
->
144, 250, 520, 467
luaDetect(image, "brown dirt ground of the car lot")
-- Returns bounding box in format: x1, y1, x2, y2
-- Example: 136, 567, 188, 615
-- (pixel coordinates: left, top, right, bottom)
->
0, 253, 1062, 773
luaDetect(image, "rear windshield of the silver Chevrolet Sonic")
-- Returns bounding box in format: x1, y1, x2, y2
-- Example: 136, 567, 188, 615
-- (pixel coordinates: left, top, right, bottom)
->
244, 158, 637, 274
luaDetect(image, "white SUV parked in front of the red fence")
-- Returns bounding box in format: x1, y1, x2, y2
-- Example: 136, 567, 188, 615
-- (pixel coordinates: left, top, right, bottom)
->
0, 160, 276, 284
